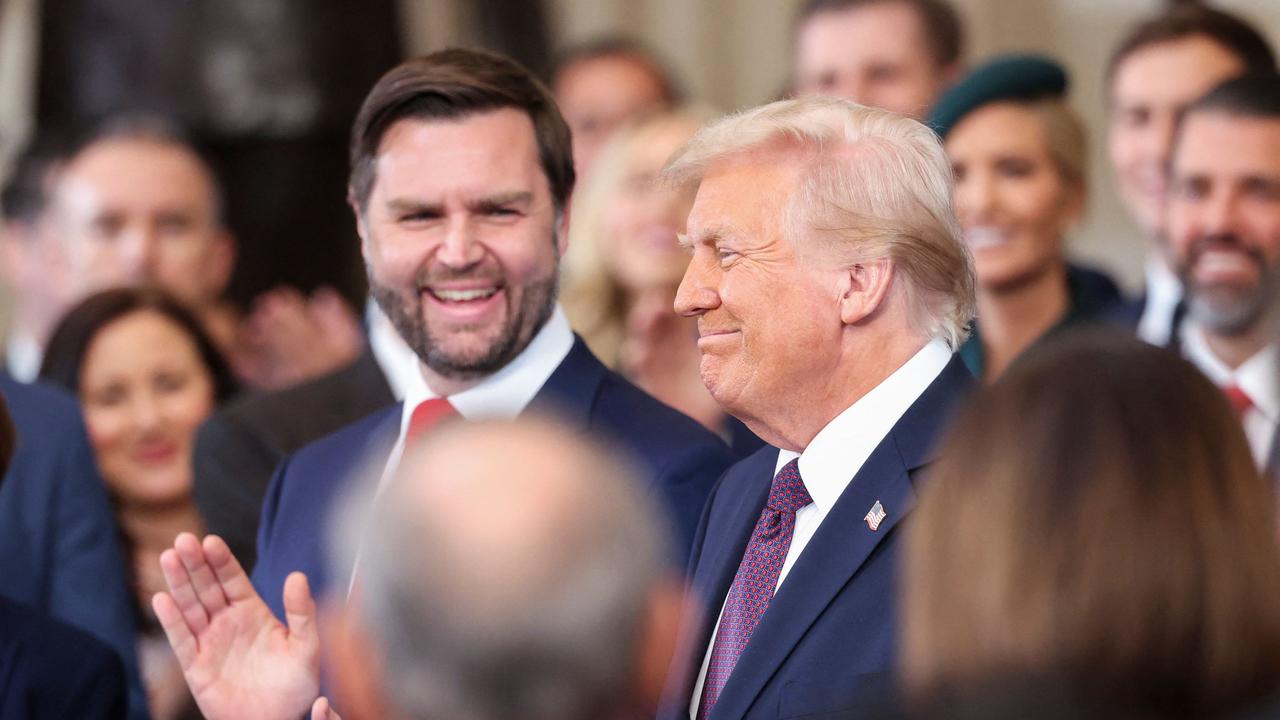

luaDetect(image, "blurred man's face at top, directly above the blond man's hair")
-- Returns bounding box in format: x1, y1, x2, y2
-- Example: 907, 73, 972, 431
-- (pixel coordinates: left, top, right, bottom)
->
795, 3, 948, 118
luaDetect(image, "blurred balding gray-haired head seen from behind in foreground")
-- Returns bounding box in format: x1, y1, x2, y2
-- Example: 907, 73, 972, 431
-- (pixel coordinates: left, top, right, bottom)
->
321, 420, 682, 720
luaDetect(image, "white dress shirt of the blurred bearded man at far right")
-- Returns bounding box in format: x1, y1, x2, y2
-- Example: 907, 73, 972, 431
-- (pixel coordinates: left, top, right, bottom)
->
1181, 322, 1280, 470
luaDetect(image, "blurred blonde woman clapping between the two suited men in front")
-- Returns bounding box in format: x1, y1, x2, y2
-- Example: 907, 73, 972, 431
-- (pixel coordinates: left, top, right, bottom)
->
561, 111, 762, 454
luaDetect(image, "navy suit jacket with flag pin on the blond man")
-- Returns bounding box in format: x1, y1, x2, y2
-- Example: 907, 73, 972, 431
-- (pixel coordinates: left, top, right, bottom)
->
662, 355, 974, 720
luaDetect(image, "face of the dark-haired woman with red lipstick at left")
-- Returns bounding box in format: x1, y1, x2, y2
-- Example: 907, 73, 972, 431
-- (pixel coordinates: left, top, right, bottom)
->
81, 310, 214, 505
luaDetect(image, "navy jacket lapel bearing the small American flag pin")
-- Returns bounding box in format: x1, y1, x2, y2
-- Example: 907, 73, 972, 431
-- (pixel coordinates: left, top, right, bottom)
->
703, 355, 973, 719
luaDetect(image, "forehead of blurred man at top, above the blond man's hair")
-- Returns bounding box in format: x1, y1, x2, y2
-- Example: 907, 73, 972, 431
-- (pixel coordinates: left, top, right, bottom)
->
796, 3, 931, 65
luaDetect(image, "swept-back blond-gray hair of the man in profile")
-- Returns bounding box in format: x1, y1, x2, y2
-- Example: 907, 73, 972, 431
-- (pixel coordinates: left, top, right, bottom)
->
663, 97, 974, 348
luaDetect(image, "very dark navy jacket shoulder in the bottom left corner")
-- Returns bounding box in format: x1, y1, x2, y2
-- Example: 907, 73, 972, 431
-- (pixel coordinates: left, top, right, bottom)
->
0, 597, 128, 720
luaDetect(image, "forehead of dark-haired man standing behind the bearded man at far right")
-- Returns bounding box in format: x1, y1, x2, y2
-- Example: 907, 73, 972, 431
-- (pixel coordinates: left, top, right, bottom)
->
1111, 35, 1244, 104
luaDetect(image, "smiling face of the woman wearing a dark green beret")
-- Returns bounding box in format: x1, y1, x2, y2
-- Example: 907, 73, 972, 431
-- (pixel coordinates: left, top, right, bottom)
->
946, 102, 1080, 291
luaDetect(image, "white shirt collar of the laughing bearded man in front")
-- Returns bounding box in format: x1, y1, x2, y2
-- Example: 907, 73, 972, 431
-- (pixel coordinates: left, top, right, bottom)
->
401, 304, 573, 437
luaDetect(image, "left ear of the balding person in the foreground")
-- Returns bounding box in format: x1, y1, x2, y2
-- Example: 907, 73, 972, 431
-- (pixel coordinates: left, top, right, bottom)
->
319, 600, 389, 720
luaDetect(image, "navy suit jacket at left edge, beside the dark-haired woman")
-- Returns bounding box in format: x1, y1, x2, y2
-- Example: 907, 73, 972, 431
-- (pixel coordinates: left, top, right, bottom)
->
0, 374, 147, 719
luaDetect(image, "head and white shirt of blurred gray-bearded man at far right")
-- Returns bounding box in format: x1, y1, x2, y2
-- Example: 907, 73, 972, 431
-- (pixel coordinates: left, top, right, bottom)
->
1167, 73, 1280, 477
